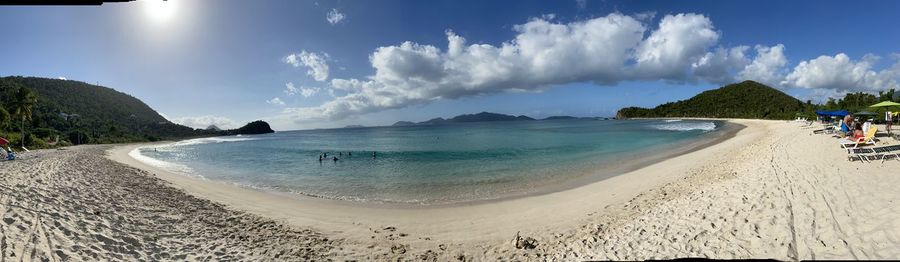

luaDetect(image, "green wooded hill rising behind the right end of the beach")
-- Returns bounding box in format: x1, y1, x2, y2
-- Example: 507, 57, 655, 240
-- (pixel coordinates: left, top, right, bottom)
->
616, 80, 814, 119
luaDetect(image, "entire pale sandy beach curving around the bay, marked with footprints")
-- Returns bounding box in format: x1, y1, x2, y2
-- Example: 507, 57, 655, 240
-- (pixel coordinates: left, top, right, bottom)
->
0, 120, 900, 261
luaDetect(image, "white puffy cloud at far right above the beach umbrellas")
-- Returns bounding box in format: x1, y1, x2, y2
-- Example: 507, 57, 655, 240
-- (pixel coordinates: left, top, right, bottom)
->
782, 53, 900, 92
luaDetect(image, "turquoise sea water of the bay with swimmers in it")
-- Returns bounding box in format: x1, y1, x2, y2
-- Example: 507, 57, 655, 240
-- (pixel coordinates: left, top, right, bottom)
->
132, 120, 722, 204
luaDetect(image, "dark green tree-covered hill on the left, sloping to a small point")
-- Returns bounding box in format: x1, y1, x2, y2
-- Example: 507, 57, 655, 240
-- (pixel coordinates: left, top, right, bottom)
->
0, 76, 274, 148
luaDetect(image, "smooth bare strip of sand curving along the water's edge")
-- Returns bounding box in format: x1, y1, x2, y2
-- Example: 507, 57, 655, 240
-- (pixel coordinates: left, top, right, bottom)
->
108, 120, 760, 244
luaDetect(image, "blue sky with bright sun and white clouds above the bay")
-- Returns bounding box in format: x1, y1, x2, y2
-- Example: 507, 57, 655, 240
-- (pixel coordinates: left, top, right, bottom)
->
0, 0, 900, 130
